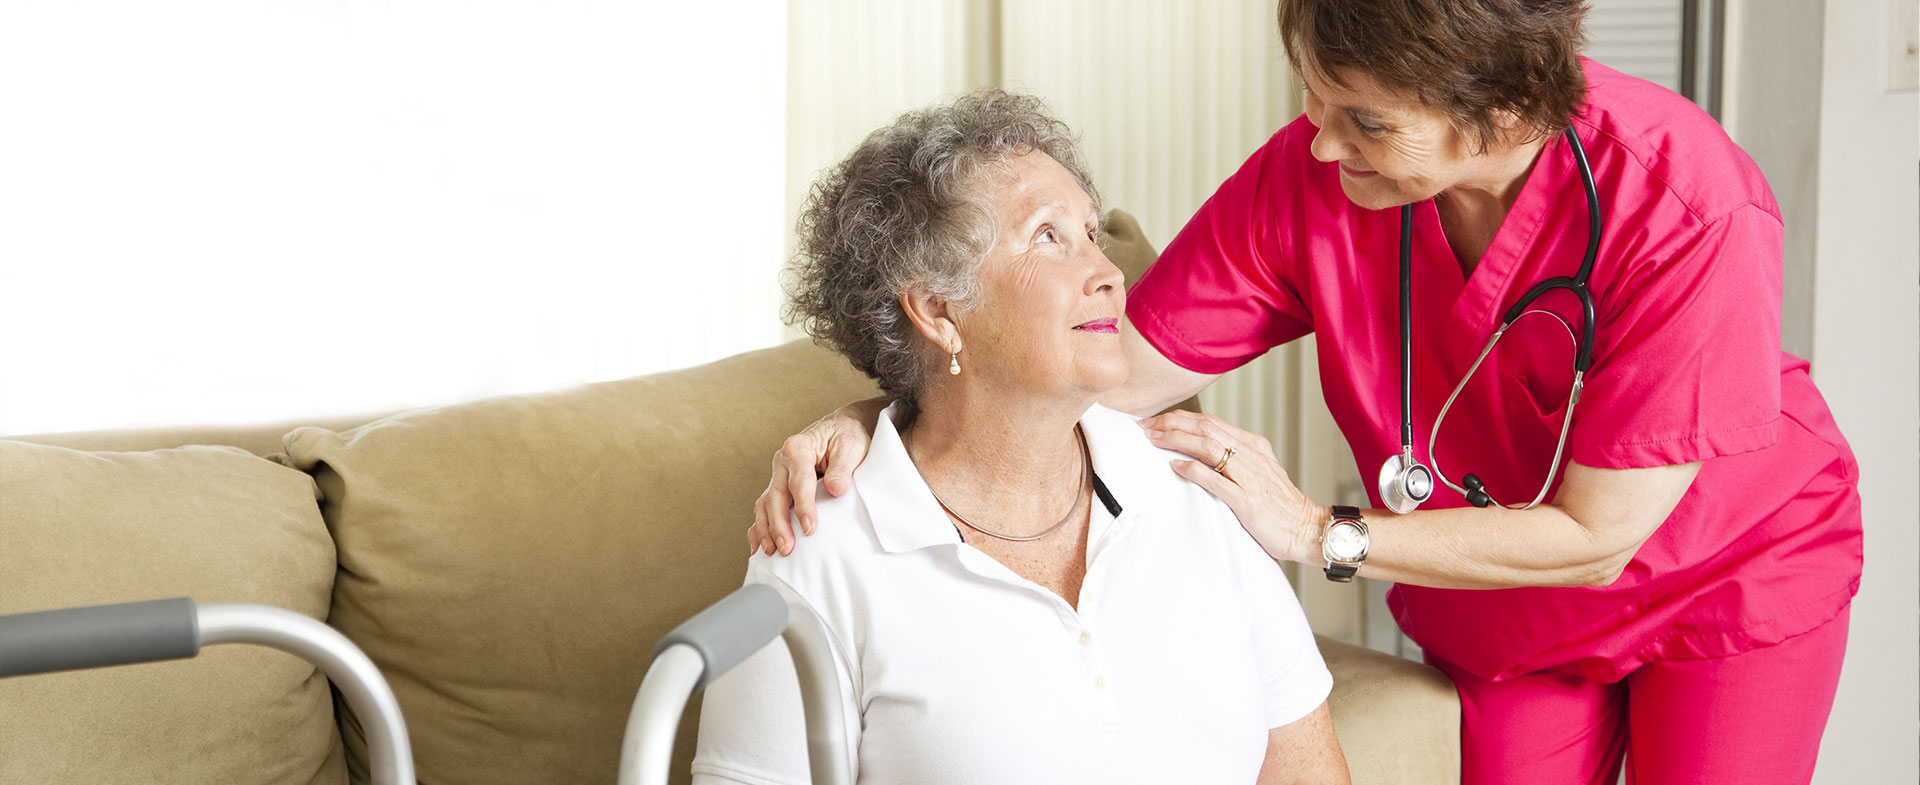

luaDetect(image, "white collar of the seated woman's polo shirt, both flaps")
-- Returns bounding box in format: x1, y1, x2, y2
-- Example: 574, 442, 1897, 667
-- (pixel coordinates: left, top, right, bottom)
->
852, 403, 1187, 553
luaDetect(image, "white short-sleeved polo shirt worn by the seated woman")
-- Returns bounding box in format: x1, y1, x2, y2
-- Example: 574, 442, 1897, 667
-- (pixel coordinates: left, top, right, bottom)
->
693, 407, 1332, 785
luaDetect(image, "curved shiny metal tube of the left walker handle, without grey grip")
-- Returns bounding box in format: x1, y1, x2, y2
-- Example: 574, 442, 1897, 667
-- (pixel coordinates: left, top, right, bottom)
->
200, 605, 415, 785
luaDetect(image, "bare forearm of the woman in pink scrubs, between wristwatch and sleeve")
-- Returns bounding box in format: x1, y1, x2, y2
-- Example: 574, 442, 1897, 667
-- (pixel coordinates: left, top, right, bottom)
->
1351, 505, 1640, 589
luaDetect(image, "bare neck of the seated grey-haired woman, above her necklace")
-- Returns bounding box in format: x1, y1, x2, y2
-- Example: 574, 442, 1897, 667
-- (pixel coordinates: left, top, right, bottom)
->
910, 384, 1092, 532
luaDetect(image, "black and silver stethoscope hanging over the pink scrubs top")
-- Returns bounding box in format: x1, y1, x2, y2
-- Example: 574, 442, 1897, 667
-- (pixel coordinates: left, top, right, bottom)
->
1380, 127, 1601, 512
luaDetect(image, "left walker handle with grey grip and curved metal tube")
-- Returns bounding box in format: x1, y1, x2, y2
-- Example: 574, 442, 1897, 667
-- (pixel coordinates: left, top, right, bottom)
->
0, 597, 413, 785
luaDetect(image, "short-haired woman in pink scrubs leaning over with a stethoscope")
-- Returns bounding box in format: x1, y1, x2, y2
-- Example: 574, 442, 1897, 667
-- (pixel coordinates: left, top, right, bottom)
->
753, 0, 1860, 783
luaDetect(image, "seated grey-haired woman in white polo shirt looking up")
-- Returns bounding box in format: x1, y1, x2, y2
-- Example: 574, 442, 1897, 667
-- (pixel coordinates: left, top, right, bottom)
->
693, 92, 1348, 783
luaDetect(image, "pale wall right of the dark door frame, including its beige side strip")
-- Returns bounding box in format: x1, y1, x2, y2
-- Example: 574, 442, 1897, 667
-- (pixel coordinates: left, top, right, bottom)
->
1724, 0, 1920, 783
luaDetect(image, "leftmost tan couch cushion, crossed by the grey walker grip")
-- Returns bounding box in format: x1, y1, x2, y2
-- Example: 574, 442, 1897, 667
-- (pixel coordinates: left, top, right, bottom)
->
0, 441, 346, 785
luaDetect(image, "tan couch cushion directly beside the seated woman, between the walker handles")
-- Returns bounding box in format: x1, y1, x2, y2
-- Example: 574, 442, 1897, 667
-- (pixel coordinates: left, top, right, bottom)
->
286, 342, 876, 785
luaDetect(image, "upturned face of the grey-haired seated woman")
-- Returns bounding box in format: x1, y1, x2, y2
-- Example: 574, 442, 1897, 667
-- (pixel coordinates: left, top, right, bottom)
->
956, 152, 1127, 395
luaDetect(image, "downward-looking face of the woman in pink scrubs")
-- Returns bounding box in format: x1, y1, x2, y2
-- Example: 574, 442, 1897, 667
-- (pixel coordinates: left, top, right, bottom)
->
1302, 67, 1496, 209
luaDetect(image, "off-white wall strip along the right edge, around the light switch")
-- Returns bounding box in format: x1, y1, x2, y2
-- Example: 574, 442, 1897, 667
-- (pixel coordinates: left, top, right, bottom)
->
1797, 0, 1920, 783
